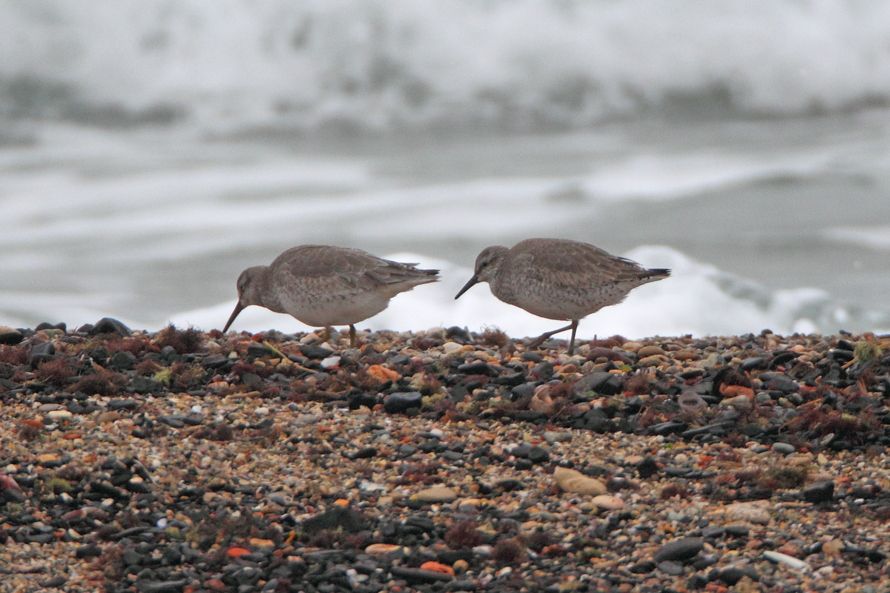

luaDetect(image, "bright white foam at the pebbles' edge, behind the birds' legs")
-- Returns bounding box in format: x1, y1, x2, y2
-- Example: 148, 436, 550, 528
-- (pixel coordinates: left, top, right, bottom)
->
165, 246, 849, 338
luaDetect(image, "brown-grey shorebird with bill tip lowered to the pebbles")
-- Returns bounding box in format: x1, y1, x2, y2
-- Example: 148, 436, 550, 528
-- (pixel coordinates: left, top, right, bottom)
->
223, 245, 439, 346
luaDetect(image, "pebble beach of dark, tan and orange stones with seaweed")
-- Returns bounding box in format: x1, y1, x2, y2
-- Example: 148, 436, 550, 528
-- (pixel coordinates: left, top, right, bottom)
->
0, 318, 890, 593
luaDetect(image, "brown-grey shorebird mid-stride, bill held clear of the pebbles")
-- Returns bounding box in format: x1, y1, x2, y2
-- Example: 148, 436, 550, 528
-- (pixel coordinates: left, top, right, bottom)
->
454, 239, 671, 355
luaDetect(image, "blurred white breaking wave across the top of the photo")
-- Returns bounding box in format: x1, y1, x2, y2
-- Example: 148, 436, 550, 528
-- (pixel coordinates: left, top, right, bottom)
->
0, 0, 890, 130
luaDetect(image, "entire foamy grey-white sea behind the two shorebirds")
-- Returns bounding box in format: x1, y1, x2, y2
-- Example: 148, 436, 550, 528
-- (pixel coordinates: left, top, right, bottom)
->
0, 0, 890, 336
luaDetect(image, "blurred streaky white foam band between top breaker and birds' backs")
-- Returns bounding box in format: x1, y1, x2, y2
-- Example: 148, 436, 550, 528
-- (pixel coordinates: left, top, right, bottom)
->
0, 134, 840, 267
